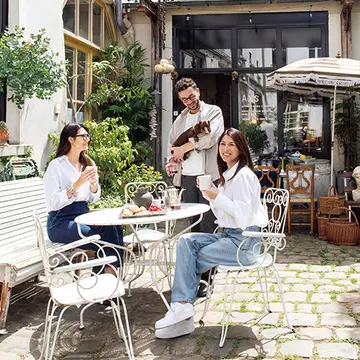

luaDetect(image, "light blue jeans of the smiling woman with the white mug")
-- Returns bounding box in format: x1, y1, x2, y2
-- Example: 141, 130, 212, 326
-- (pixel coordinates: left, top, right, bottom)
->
171, 226, 260, 304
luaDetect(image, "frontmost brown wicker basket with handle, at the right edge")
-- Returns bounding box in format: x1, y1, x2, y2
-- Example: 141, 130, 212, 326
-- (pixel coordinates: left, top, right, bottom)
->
326, 207, 360, 246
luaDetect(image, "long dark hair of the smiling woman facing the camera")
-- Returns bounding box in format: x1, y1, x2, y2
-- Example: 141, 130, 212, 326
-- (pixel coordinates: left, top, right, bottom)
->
217, 128, 254, 185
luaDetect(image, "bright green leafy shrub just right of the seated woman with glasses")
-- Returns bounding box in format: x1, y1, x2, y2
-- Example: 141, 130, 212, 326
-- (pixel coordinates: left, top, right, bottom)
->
85, 118, 135, 191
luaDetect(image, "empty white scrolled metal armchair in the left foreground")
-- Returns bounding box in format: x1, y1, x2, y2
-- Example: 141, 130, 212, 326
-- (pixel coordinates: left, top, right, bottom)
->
34, 214, 135, 360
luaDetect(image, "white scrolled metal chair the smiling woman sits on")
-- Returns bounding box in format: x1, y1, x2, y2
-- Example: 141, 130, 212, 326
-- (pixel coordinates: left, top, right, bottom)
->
199, 188, 294, 347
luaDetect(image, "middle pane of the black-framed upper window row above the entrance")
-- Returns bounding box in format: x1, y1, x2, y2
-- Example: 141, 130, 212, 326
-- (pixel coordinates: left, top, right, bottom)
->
237, 28, 276, 67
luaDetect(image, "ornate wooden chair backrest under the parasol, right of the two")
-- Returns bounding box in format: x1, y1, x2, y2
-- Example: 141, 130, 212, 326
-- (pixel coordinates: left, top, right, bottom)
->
286, 165, 314, 198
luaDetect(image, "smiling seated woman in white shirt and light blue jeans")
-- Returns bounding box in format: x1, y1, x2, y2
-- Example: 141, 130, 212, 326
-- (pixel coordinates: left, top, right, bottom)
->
155, 128, 268, 339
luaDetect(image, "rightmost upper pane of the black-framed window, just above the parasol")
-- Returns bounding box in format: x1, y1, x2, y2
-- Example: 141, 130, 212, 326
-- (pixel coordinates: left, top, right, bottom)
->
282, 27, 322, 64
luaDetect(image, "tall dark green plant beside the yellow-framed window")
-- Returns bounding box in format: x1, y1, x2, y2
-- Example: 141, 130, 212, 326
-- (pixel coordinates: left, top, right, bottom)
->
86, 41, 154, 144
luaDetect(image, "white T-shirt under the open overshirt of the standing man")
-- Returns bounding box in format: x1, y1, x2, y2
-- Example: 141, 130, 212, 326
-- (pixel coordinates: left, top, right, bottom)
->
182, 112, 205, 176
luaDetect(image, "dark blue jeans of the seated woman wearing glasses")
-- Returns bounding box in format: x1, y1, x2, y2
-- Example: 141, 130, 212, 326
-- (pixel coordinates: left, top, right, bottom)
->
47, 201, 123, 265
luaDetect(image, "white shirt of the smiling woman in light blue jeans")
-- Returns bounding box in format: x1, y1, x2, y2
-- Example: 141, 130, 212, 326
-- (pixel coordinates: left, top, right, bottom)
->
210, 164, 268, 230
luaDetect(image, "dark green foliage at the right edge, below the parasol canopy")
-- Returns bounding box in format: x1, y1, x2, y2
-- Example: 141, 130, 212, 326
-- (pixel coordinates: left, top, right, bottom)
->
334, 97, 360, 171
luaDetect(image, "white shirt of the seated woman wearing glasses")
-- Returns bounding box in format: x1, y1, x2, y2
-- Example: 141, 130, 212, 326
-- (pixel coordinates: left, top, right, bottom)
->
44, 155, 100, 212
